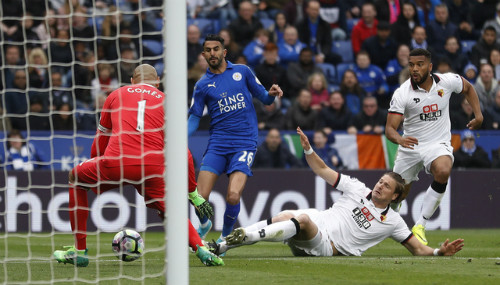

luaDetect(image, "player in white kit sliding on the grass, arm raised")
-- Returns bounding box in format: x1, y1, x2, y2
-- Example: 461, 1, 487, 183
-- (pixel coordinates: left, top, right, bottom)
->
211, 128, 464, 256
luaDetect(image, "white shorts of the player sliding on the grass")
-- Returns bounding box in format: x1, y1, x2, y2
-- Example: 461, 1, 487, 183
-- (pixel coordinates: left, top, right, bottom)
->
286, 209, 333, 256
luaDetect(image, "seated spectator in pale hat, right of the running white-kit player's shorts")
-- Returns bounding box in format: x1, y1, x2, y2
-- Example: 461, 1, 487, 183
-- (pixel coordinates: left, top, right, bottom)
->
453, 130, 491, 168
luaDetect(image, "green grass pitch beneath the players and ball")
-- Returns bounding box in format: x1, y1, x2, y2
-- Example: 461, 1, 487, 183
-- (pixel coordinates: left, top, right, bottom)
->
0, 229, 500, 285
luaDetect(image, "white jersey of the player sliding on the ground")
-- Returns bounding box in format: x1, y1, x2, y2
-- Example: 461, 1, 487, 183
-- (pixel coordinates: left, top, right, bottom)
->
315, 174, 412, 256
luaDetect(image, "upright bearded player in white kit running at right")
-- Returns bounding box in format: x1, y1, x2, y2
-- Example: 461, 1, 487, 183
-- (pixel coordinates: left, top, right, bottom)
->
385, 49, 483, 245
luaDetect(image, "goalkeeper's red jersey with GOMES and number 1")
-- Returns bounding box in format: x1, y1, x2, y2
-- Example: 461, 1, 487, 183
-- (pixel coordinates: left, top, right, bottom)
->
99, 84, 165, 166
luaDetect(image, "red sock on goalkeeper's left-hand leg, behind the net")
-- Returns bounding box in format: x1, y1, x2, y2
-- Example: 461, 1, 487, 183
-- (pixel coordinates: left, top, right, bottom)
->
69, 185, 89, 250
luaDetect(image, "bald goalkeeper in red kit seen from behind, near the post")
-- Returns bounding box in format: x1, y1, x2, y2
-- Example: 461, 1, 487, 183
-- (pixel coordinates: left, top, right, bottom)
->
54, 64, 224, 267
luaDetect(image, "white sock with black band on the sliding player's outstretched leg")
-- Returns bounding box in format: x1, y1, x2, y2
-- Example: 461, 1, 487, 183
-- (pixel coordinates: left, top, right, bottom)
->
245, 219, 300, 243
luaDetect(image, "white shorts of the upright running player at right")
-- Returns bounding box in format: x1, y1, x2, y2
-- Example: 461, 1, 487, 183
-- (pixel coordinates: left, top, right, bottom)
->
393, 142, 454, 184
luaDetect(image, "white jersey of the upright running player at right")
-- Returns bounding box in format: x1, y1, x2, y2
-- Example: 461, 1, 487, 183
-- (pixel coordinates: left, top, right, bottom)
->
389, 73, 463, 144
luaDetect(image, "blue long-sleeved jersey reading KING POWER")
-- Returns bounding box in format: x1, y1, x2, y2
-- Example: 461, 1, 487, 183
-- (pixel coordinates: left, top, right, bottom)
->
189, 61, 274, 151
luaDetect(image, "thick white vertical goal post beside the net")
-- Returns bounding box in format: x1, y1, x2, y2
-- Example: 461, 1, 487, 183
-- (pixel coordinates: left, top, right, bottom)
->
164, 1, 189, 285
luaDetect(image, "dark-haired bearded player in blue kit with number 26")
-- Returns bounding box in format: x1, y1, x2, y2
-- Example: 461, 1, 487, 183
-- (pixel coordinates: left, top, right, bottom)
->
188, 35, 283, 246
